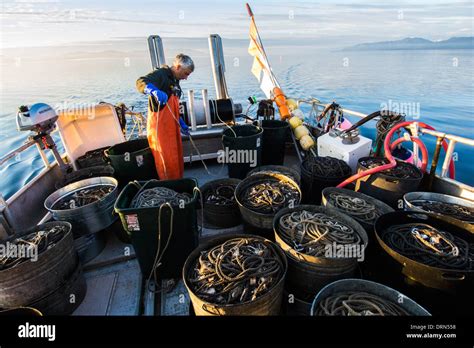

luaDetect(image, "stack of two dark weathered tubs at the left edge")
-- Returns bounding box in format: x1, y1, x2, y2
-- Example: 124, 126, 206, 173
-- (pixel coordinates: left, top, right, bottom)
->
0, 222, 87, 315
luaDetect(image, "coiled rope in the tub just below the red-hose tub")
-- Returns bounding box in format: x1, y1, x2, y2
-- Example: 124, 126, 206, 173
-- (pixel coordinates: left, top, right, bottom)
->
327, 192, 382, 225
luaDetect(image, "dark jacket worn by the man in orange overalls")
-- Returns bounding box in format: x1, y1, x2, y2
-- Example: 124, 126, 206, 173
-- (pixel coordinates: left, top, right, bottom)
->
137, 65, 181, 111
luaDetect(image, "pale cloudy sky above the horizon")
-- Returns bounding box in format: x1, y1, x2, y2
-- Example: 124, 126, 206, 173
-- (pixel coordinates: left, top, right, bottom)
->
0, 0, 474, 48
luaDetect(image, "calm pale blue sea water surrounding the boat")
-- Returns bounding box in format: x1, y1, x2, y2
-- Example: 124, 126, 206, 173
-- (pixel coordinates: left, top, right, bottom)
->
0, 41, 474, 198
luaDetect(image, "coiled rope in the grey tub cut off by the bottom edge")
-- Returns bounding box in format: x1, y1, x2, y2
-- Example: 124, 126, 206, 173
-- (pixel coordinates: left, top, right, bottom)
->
314, 291, 409, 316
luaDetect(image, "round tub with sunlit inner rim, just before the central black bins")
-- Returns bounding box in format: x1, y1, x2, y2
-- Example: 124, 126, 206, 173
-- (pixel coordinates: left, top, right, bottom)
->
235, 173, 301, 234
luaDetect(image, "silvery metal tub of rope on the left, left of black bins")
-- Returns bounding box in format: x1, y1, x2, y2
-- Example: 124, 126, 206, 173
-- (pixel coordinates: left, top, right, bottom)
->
44, 176, 118, 238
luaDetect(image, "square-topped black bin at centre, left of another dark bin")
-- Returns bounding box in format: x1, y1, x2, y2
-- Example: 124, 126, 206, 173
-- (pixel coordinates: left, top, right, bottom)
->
222, 124, 263, 179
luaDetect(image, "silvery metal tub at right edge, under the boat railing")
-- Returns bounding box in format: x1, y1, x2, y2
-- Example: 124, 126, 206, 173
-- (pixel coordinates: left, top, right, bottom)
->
403, 192, 474, 228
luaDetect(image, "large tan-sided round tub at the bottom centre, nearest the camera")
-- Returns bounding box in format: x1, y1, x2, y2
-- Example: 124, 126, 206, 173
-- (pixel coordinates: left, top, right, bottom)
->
182, 234, 288, 316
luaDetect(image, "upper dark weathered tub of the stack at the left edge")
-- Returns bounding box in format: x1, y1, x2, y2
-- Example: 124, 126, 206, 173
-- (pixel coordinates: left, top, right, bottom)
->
0, 222, 79, 308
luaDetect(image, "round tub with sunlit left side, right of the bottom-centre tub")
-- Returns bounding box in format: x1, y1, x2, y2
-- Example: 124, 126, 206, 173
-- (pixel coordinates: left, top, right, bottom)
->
273, 205, 368, 299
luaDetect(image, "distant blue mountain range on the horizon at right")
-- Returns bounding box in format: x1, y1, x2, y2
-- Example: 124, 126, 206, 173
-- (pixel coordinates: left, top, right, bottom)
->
343, 36, 474, 51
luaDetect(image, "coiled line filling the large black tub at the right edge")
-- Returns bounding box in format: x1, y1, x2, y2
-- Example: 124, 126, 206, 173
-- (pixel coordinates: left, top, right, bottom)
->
381, 223, 474, 270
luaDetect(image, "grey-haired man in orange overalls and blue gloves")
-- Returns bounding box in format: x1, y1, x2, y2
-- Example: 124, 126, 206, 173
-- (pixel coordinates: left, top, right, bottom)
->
137, 54, 194, 180
